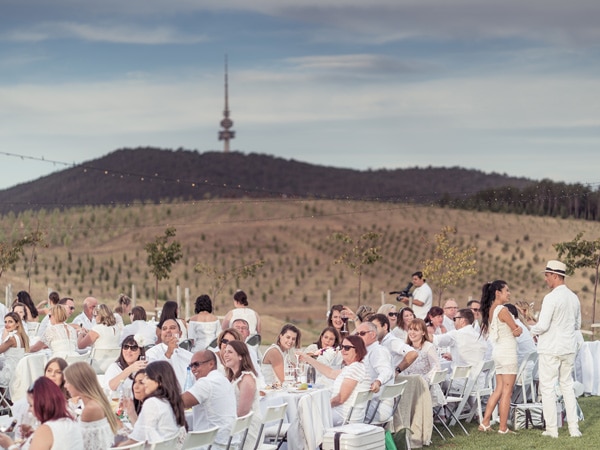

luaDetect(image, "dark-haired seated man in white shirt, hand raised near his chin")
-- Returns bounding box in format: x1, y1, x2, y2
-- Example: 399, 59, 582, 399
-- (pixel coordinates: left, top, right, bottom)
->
146, 319, 192, 392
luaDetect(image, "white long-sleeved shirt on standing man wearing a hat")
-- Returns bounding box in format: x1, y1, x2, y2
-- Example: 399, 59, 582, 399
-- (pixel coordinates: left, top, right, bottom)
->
529, 284, 581, 356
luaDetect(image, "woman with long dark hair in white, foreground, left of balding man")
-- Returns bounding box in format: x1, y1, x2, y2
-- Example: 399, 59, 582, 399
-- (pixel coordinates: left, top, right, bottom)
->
119, 361, 187, 450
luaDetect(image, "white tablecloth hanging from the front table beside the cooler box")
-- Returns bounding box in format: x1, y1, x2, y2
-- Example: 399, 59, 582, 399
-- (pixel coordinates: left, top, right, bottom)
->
260, 388, 333, 450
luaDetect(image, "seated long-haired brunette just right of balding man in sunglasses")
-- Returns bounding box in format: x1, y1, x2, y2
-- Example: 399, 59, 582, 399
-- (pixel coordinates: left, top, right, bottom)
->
224, 341, 261, 450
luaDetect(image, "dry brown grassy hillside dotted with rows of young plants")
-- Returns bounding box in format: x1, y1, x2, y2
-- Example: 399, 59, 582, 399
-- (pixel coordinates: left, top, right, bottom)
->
0, 200, 598, 342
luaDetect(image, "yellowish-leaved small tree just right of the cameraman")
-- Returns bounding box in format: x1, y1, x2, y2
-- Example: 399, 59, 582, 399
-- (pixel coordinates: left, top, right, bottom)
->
421, 226, 477, 306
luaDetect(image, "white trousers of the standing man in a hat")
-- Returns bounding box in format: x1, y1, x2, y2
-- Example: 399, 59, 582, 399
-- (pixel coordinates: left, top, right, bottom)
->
538, 353, 578, 433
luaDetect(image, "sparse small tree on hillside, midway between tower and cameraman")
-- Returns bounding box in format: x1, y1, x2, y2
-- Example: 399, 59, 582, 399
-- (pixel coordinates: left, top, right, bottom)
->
331, 231, 382, 307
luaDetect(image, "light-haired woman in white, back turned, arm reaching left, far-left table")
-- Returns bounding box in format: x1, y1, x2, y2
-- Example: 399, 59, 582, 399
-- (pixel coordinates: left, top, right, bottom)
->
30, 305, 78, 358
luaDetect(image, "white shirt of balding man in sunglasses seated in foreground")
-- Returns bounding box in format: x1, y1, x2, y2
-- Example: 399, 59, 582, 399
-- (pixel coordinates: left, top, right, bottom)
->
188, 370, 237, 446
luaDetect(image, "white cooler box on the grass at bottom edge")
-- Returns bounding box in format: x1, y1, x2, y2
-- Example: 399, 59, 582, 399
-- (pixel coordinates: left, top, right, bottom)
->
323, 423, 385, 450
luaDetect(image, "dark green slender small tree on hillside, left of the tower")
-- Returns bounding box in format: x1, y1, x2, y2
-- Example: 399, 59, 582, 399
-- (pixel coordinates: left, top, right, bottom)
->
144, 227, 183, 309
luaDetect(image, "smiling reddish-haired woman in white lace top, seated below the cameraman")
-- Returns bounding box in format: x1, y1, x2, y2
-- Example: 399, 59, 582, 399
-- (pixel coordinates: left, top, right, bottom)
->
402, 318, 445, 406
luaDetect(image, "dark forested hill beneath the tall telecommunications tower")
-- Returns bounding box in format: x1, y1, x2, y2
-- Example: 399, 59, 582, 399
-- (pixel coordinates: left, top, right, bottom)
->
0, 148, 534, 213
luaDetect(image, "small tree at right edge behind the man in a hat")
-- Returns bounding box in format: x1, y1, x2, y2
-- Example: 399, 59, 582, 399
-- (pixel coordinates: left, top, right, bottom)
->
553, 233, 600, 323
